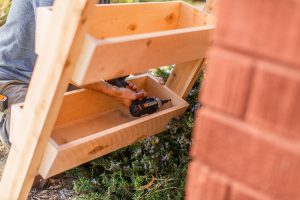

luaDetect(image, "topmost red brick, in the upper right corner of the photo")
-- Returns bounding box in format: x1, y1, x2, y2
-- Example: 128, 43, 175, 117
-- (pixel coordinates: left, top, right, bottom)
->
215, 0, 300, 67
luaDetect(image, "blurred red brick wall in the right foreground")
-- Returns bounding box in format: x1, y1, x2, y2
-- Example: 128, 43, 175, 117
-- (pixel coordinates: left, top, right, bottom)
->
186, 0, 300, 200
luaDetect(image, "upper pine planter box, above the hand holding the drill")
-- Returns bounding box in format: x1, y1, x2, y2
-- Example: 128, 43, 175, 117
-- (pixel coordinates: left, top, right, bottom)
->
72, 2, 214, 86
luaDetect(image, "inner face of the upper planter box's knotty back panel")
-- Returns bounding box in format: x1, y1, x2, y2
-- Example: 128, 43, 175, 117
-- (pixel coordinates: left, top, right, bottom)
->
88, 2, 181, 39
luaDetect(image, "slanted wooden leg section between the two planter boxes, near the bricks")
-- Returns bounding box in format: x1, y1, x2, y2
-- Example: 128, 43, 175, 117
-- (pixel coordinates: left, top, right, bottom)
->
166, 59, 205, 99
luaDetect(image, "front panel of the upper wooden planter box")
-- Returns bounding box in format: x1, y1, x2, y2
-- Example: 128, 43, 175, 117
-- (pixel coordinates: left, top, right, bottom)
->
72, 25, 214, 85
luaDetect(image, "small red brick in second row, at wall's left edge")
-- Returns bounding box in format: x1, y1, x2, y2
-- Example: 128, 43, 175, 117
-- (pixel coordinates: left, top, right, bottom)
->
200, 48, 253, 117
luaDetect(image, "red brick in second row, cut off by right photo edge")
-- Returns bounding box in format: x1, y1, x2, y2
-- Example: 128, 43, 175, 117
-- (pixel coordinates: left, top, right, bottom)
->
246, 62, 300, 142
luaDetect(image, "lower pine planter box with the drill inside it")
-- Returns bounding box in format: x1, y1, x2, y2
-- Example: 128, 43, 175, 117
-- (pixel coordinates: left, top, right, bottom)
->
39, 75, 188, 178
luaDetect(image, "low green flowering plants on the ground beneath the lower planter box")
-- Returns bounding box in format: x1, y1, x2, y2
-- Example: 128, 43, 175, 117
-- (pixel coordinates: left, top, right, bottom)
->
67, 67, 203, 200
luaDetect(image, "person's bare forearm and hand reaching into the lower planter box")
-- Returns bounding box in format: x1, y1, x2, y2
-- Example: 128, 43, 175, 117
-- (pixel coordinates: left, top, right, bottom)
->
83, 81, 145, 107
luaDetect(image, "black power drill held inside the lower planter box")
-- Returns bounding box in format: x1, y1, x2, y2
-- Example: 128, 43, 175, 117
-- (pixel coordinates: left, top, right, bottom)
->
107, 76, 171, 117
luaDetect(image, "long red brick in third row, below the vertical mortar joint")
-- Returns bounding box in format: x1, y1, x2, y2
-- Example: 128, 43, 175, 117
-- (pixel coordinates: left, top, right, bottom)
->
191, 108, 300, 200
